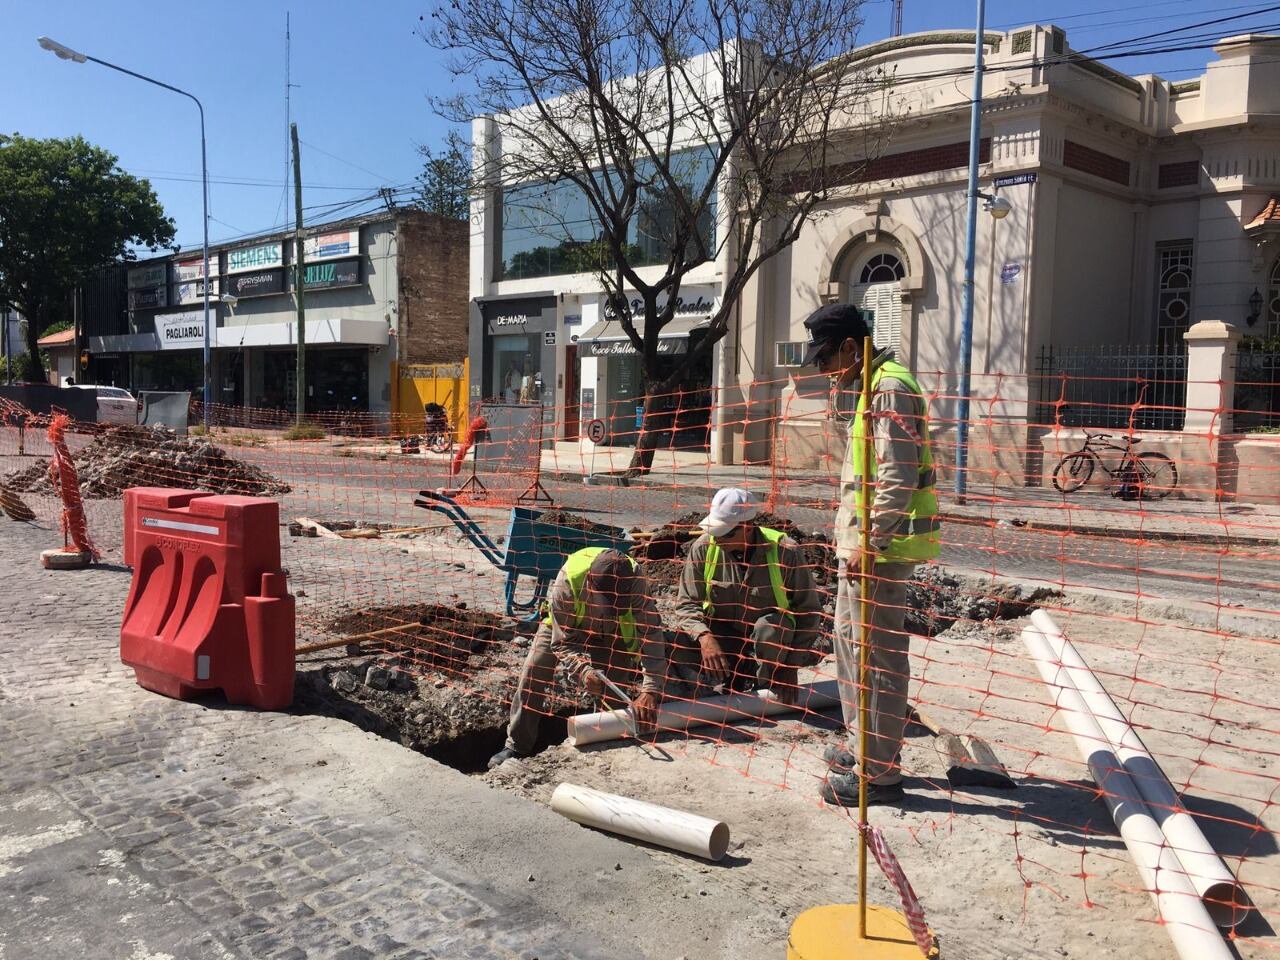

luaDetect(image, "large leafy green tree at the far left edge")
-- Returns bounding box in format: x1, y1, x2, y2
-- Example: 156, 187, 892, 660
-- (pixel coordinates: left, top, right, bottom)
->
0, 133, 174, 375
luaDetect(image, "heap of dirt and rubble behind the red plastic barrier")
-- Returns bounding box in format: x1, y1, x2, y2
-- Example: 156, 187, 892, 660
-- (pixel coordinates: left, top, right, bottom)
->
5, 426, 291, 499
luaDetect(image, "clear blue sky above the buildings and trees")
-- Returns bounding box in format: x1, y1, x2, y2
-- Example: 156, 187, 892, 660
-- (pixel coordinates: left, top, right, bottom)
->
0, 0, 1280, 250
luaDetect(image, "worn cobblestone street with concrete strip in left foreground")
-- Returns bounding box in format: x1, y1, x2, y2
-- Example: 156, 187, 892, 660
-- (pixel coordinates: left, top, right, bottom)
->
0, 524, 767, 960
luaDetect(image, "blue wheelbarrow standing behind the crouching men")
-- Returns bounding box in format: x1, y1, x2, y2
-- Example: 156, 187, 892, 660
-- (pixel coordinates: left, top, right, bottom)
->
413, 490, 632, 622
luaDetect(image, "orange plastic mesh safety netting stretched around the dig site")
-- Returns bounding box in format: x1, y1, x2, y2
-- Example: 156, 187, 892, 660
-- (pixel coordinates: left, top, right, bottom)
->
0, 371, 1280, 959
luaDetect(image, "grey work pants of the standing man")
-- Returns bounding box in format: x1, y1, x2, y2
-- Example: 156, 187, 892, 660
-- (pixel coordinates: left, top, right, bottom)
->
835, 561, 915, 785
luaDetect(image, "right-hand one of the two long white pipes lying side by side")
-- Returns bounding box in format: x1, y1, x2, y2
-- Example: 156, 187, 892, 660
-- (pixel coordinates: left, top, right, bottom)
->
1032, 611, 1249, 929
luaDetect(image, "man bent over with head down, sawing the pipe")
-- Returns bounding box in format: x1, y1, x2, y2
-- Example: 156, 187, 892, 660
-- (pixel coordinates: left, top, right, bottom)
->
489, 547, 667, 769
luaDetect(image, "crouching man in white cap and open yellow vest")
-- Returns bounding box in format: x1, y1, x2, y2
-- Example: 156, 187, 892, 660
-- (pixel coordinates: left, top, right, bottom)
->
676, 488, 822, 703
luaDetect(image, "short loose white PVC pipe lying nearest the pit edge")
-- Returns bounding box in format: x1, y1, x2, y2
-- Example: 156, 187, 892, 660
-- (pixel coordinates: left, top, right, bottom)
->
552, 783, 728, 860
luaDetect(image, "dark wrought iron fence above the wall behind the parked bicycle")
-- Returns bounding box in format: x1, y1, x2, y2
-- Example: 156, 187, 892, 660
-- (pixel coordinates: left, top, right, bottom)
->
1036, 344, 1187, 430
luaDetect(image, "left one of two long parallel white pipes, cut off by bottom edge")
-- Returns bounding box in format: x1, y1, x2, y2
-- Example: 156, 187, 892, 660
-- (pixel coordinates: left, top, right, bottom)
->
1023, 627, 1231, 960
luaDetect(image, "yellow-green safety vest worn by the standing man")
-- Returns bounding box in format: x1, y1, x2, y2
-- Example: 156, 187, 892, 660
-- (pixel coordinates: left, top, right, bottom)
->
849, 360, 941, 563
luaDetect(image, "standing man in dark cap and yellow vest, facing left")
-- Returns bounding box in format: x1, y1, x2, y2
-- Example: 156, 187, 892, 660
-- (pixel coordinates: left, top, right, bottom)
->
804, 303, 940, 806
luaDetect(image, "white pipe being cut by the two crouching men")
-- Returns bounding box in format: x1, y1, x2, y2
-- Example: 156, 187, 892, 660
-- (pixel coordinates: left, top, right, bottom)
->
568, 680, 840, 746
